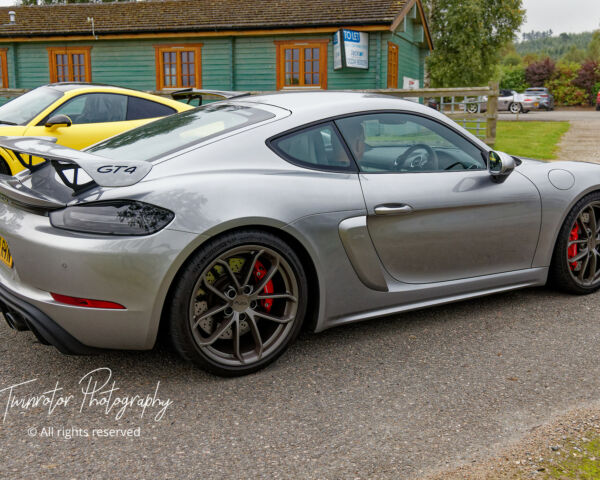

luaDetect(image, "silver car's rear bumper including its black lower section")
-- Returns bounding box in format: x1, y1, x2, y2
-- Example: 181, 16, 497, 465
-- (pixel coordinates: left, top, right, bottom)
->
0, 197, 201, 353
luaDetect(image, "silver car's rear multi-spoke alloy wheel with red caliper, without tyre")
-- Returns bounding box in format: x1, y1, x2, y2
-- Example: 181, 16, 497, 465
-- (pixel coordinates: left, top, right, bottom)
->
189, 245, 299, 366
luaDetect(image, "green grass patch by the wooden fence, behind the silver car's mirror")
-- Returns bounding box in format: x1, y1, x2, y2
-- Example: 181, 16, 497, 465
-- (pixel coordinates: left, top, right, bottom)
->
495, 122, 570, 160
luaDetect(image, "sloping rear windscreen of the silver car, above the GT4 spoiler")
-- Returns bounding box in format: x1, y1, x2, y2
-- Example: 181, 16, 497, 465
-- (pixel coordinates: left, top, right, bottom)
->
87, 103, 275, 161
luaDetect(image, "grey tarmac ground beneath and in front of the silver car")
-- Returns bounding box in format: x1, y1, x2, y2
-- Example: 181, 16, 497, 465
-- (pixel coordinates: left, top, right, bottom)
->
0, 289, 600, 479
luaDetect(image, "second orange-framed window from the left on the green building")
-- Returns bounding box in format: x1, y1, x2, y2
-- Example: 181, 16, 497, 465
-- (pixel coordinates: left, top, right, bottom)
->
48, 47, 92, 82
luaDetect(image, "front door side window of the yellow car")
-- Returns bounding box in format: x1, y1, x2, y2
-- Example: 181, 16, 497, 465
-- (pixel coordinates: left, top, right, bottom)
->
49, 93, 128, 125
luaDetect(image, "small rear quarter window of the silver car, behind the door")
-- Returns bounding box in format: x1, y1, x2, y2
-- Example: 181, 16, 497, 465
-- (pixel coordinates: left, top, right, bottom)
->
270, 122, 356, 171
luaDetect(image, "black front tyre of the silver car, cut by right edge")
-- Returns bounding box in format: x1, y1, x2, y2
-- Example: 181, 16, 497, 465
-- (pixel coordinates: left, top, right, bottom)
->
548, 192, 600, 295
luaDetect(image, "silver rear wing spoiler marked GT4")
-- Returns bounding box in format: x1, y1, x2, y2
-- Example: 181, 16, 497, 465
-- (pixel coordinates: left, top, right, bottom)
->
0, 137, 152, 193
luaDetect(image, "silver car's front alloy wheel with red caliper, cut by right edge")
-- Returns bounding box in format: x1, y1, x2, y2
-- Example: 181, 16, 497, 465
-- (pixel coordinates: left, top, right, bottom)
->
565, 202, 600, 287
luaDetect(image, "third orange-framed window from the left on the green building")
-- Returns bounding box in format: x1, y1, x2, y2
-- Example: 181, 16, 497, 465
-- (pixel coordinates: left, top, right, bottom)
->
154, 43, 202, 90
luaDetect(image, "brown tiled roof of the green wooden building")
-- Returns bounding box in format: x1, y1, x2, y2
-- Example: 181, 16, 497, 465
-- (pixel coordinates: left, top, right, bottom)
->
0, 0, 427, 38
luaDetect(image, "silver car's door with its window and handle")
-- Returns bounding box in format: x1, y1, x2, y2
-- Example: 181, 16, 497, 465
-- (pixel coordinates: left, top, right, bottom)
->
336, 113, 541, 283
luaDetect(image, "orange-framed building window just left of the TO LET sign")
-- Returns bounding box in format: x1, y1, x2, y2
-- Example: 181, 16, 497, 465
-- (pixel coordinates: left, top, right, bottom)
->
275, 40, 328, 90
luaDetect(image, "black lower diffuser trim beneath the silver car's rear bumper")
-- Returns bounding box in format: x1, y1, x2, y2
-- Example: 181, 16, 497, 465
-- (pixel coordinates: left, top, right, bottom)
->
0, 285, 100, 355
